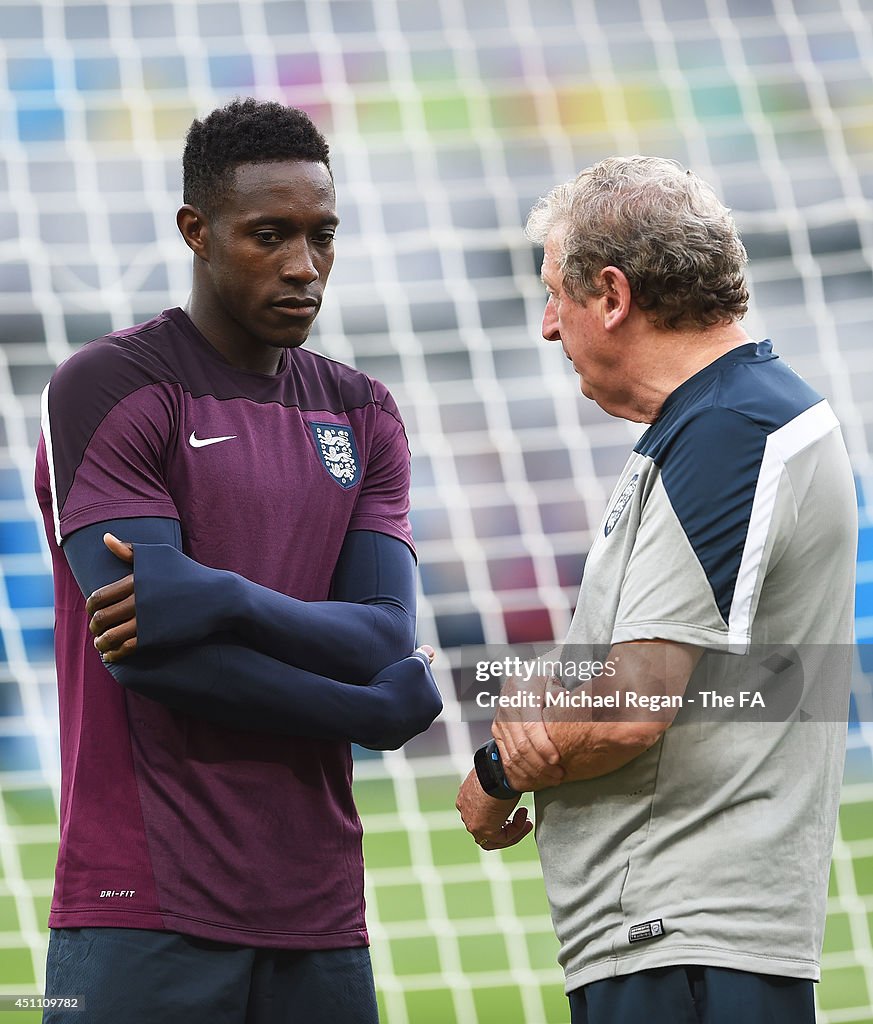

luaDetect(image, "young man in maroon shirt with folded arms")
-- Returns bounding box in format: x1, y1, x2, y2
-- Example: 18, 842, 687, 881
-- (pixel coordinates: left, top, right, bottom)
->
36, 99, 440, 1024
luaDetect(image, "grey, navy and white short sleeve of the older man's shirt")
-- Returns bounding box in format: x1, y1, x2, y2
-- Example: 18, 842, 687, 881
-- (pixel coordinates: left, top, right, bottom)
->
613, 408, 796, 652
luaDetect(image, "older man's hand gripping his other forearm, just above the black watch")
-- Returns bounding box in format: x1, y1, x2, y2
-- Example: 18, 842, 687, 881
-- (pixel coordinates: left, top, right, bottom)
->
491, 679, 565, 792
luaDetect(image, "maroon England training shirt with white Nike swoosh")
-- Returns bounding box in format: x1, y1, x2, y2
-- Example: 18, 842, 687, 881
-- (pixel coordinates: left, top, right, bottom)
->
36, 309, 411, 949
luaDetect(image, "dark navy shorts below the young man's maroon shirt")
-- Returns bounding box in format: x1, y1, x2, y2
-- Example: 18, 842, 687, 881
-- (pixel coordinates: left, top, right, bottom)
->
43, 928, 379, 1024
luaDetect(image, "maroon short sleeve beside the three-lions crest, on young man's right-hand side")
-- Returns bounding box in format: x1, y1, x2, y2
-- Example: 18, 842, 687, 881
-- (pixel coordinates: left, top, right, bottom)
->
348, 382, 416, 555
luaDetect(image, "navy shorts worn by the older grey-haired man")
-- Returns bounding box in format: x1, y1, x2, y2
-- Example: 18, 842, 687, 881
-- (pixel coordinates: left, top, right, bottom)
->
569, 966, 816, 1024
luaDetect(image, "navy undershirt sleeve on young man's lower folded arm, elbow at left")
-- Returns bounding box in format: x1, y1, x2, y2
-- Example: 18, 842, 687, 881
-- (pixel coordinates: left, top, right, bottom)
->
63, 518, 442, 750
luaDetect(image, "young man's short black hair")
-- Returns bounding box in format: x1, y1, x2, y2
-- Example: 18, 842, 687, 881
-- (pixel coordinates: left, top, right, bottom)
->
182, 97, 331, 216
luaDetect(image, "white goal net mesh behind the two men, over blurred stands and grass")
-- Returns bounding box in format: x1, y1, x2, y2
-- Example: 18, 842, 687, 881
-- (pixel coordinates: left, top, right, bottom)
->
0, 0, 873, 1024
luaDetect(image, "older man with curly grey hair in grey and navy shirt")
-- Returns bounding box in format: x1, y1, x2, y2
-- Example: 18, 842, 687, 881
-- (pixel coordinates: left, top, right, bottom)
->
457, 157, 857, 1024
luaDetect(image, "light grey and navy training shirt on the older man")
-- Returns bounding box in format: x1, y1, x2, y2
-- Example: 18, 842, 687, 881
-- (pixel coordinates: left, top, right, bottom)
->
536, 342, 857, 991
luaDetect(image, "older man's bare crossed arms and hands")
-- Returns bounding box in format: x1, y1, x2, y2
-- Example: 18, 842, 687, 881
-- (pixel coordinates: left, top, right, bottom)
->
456, 640, 703, 850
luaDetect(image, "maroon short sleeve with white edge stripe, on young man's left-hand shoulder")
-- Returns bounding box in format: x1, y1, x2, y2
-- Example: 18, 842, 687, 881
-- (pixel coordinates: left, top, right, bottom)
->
42, 339, 179, 544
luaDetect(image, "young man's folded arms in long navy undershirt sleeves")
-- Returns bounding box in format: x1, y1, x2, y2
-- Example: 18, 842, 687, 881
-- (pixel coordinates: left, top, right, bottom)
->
64, 518, 442, 749
